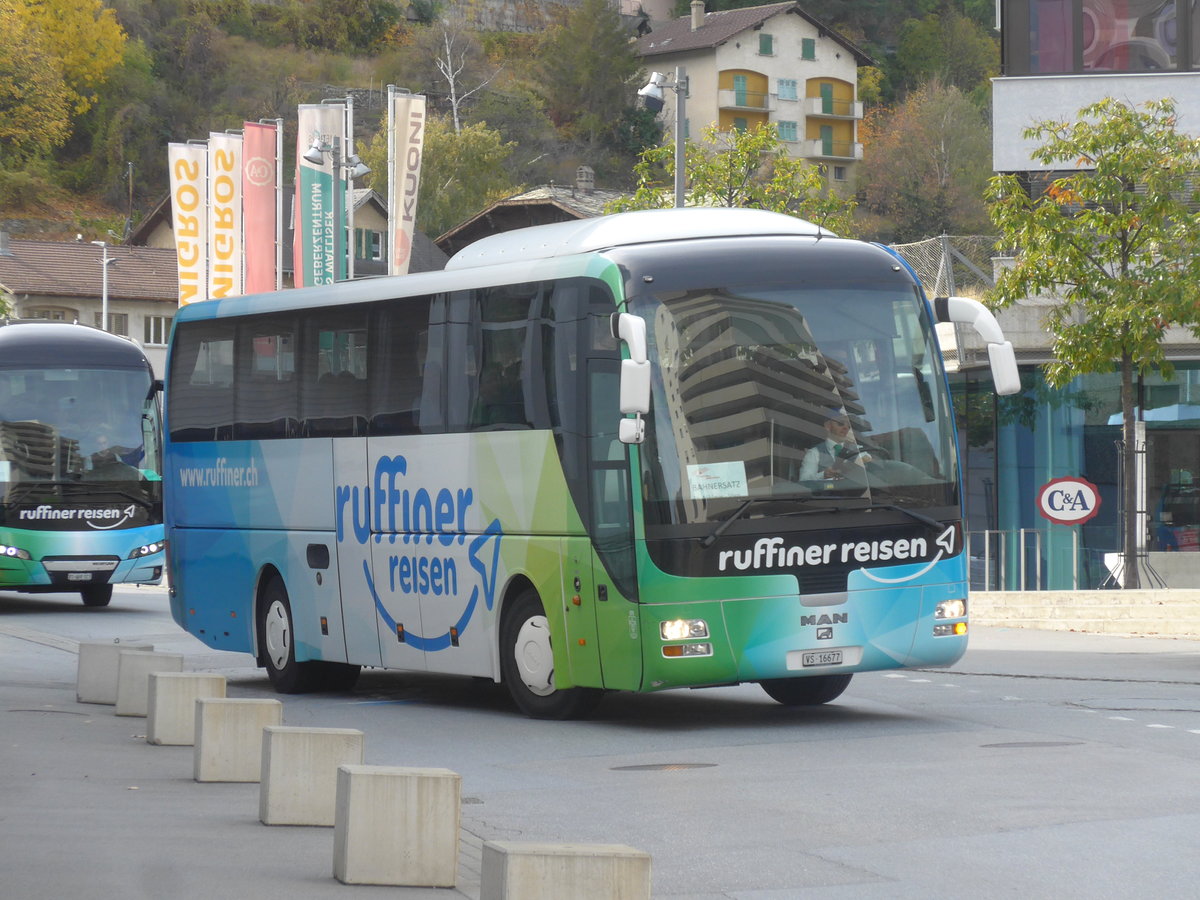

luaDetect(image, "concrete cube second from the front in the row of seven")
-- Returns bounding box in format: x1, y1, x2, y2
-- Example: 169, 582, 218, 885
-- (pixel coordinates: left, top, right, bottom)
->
334, 766, 462, 888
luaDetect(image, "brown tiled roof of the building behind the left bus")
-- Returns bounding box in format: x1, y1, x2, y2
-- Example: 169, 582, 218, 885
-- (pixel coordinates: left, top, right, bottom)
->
0, 240, 179, 302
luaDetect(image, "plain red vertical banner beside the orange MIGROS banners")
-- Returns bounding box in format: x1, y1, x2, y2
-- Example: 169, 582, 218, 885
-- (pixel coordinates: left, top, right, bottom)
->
241, 122, 280, 294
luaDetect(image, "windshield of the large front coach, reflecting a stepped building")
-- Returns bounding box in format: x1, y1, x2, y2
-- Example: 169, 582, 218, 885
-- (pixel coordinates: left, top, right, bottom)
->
631, 278, 958, 524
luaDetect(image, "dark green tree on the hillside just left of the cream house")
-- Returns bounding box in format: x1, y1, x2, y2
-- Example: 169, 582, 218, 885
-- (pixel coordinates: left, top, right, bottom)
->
535, 0, 640, 144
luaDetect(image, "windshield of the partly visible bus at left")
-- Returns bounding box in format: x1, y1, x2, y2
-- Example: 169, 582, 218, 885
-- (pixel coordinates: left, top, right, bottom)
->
0, 367, 162, 502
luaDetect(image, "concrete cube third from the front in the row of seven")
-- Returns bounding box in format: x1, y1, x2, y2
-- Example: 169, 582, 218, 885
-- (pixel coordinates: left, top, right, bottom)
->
258, 725, 362, 826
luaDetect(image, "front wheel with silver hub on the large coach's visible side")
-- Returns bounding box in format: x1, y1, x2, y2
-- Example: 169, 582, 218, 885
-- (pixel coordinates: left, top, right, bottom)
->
500, 588, 604, 719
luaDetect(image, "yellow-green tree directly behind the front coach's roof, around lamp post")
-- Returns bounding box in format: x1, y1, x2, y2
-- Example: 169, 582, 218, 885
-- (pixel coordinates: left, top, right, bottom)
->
607, 125, 854, 235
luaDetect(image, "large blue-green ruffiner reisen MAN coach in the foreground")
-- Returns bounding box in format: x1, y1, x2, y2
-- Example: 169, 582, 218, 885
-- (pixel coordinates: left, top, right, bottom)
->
164, 209, 1019, 718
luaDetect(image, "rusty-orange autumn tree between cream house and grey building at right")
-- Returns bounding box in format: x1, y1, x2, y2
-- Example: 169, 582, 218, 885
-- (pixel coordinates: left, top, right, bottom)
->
858, 82, 991, 242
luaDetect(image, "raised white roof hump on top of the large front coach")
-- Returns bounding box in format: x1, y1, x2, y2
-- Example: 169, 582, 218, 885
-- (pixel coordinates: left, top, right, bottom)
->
446, 206, 834, 269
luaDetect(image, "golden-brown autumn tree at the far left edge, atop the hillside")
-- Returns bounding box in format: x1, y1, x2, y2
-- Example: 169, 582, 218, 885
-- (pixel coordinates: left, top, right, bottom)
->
0, 0, 71, 160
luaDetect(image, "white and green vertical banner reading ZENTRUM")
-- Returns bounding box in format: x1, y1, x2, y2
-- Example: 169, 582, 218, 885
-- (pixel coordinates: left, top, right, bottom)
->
293, 103, 346, 288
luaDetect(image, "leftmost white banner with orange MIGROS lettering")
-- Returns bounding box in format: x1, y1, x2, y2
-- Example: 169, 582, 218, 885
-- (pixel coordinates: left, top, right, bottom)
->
167, 144, 209, 306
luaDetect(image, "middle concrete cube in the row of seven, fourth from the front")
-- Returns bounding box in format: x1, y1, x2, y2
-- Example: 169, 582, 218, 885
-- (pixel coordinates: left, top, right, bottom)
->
193, 697, 283, 781
